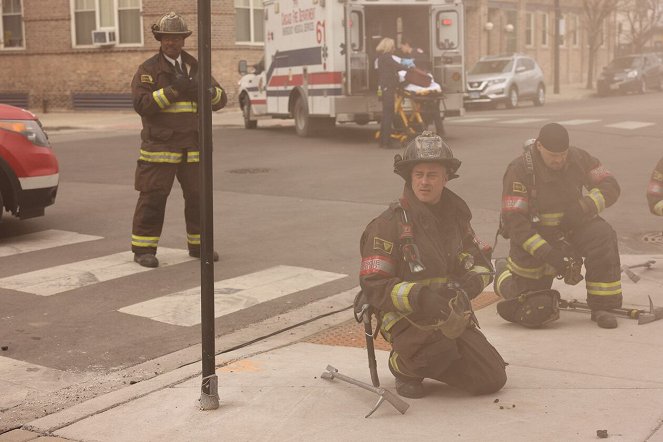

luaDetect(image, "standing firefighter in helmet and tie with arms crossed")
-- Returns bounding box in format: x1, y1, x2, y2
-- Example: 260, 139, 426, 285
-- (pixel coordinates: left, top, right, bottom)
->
131, 12, 227, 267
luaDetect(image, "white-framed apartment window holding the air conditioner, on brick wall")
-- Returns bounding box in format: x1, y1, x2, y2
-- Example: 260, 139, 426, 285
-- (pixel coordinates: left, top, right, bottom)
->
72, 0, 143, 46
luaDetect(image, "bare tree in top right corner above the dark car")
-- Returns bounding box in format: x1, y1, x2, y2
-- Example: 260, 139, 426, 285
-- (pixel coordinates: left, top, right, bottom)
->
620, 0, 663, 53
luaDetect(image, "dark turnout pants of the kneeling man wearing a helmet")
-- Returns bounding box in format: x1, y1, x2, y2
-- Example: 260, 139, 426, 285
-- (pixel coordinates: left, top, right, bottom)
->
389, 327, 506, 394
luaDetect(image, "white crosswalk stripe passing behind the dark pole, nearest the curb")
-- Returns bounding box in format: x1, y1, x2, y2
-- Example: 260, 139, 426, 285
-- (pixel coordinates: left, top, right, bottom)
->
119, 266, 347, 327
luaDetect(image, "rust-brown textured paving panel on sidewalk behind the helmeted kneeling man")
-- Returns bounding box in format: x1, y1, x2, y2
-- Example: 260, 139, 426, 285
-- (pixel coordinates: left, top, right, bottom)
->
305, 292, 500, 350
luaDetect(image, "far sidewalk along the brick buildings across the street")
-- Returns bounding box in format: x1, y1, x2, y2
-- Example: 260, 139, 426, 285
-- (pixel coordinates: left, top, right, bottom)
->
35, 84, 595, 134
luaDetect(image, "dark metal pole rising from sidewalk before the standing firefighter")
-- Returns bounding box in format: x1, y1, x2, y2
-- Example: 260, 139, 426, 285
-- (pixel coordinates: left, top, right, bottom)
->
198, 0, 219, 410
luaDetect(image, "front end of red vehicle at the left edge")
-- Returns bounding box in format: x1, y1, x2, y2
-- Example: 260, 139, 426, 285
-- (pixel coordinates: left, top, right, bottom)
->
0, 104, 59, 220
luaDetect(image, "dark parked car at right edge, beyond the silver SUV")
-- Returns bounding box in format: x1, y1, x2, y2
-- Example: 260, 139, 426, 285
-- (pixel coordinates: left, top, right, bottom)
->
596, 54, 663, 96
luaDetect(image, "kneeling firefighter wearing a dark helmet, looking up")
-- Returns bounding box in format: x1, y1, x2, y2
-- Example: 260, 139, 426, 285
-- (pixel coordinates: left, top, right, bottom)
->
360, 132, 506, 398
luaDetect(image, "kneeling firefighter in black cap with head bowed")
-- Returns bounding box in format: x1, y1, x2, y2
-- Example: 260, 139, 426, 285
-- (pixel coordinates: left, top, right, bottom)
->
495, 123, 622, 328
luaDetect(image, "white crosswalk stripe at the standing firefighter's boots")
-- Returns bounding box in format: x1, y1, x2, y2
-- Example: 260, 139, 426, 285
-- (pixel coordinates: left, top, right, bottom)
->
0, 247, 195, 296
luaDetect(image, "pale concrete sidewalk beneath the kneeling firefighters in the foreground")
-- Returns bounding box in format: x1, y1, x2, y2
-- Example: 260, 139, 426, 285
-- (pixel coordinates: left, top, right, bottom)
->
0, 255, 663, 442
